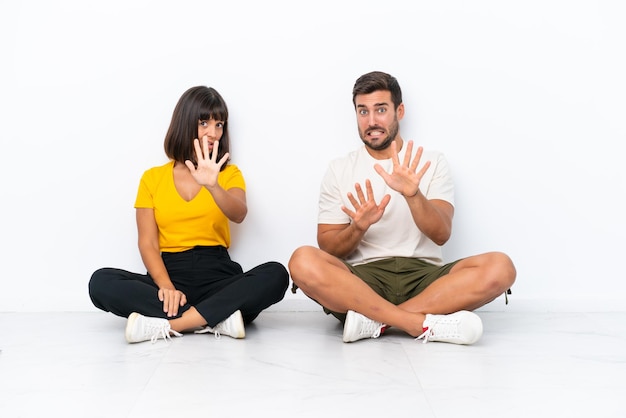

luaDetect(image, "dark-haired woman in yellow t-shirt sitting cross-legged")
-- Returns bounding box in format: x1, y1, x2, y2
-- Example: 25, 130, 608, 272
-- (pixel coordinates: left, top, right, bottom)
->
89, 86, 289, 343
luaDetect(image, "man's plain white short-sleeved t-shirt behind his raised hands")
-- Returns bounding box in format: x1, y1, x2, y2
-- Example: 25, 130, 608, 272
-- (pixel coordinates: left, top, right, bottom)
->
318, 142, 454, 265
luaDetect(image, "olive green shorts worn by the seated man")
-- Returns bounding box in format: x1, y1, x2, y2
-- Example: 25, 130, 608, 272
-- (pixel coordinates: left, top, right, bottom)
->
324, 257, 460, 322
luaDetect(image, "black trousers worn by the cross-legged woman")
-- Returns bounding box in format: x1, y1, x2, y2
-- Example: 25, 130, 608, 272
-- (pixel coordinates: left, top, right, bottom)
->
89, 246, 289, 327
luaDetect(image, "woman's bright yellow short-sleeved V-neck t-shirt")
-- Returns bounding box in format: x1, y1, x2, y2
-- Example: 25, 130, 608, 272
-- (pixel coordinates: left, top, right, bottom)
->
135, 161, 246, 252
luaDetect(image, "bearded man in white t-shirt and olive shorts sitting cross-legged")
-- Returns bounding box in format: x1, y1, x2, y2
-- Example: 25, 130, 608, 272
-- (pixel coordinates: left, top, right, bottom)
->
289, 71, 516, 344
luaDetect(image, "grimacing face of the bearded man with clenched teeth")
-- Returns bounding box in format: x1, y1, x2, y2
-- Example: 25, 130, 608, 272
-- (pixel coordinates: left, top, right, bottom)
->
355, 90, 402, 151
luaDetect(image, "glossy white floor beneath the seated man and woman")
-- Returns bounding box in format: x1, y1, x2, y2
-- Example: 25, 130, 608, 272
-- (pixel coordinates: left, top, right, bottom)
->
0, 312, 626, 418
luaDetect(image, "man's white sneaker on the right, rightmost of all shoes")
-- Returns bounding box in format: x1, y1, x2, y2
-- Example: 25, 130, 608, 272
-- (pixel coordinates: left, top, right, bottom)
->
416, 311, 483, 344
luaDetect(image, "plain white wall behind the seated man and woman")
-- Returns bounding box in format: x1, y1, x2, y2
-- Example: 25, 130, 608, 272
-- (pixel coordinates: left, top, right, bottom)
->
0, 0, 626, 312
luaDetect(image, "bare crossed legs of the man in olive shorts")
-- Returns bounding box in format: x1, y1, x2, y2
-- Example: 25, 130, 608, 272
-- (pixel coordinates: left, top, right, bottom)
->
289, 246, 516, 337
